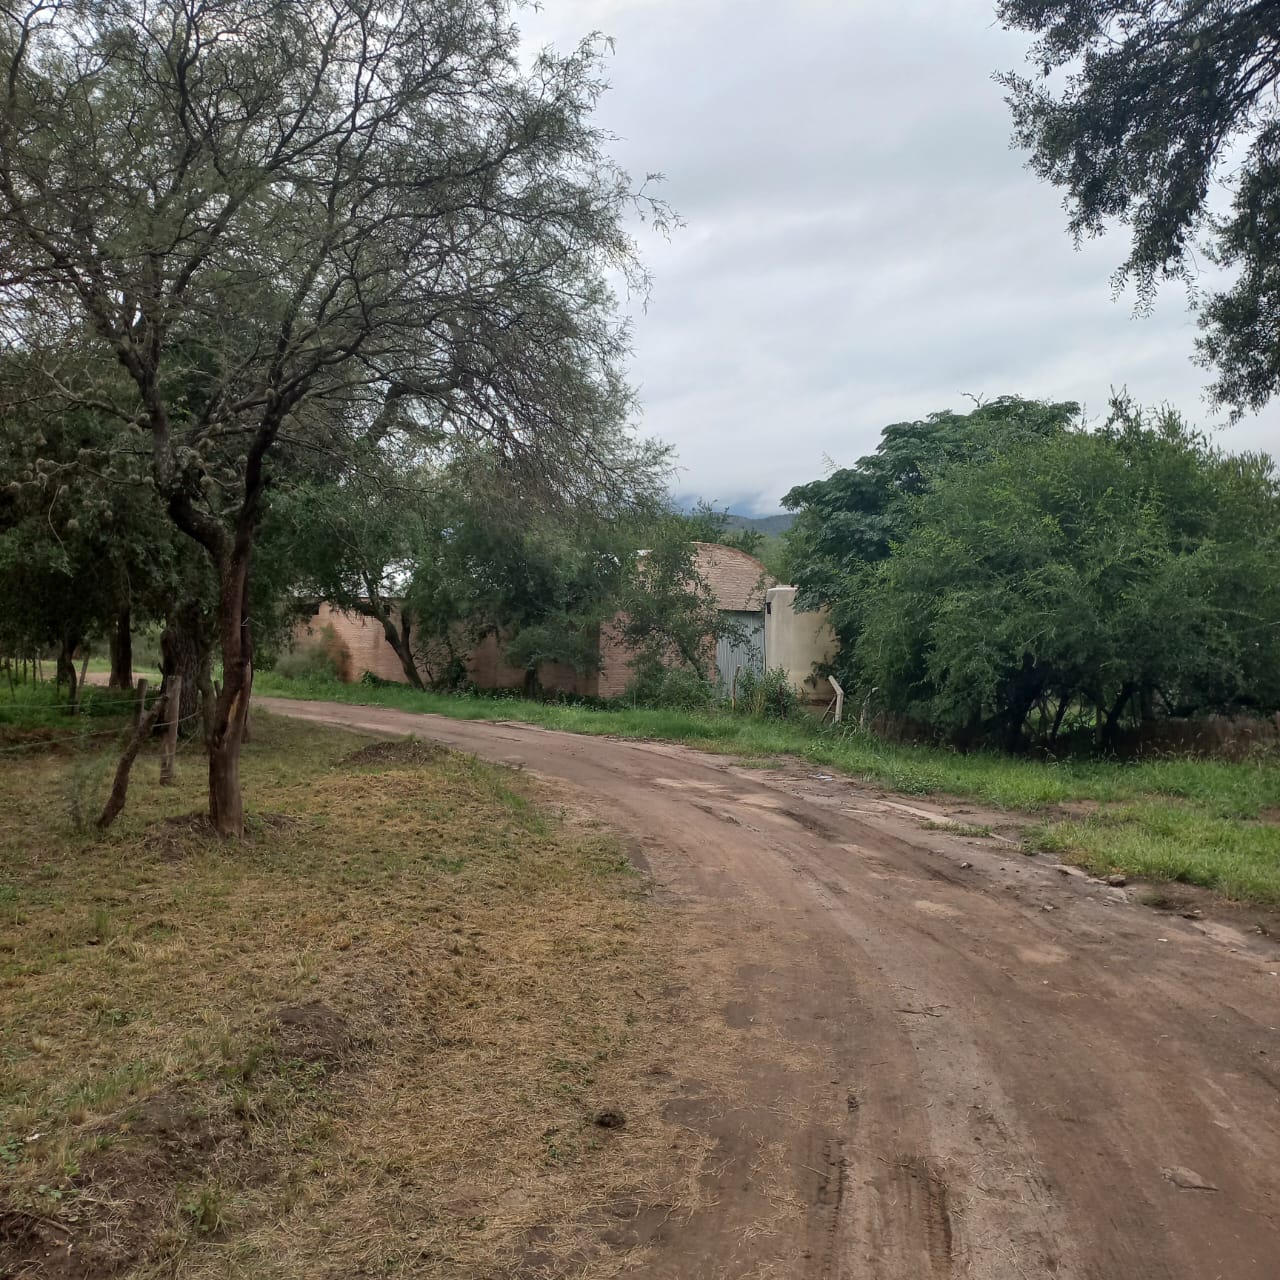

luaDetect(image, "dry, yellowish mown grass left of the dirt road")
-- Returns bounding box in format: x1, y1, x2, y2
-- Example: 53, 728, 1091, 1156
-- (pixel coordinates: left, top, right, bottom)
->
0, 716, 696, 1280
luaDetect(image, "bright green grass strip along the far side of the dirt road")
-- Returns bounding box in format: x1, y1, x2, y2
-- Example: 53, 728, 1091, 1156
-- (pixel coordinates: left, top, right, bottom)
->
255, 672, 1280, 906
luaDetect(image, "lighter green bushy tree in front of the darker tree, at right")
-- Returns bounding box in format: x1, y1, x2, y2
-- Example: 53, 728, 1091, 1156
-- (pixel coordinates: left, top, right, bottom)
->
852, 404, 1280, 748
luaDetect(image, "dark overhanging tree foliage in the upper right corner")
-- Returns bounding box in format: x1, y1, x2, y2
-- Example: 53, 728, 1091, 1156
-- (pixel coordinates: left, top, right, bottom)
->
997, 0, 1280, 411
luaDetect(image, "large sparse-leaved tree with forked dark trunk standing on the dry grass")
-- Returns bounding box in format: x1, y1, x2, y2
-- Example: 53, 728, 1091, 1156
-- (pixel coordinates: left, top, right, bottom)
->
0, 0, 660, 835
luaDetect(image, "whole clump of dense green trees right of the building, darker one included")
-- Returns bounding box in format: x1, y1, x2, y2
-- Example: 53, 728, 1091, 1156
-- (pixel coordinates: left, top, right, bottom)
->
786, 397, 1280, 755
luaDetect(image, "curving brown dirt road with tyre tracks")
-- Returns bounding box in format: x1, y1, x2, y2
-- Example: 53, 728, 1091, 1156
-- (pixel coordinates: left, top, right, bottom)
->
260, 699, 1280, 1280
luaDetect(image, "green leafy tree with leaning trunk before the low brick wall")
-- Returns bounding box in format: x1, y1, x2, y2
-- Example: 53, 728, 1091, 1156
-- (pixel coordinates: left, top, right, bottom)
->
275, 435, 667, 687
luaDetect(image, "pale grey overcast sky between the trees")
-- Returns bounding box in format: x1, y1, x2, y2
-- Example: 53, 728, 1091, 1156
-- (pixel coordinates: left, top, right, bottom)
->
520, 0, 1280, 513
